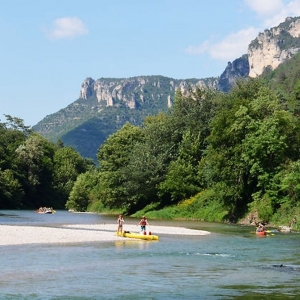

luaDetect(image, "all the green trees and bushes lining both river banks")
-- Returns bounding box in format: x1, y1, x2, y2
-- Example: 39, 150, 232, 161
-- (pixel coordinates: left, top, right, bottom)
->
0, 55, 300, 229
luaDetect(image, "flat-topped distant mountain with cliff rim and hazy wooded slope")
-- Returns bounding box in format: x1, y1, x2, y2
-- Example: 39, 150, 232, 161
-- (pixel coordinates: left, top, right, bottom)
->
33, 76, 218, 159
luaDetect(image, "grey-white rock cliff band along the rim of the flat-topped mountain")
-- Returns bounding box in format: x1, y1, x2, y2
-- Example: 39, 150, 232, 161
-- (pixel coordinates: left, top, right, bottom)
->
79, 76, 218, 110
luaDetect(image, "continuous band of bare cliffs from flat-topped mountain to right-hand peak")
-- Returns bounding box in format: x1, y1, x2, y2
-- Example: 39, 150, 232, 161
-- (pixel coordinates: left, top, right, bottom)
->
62, 17, 300, 118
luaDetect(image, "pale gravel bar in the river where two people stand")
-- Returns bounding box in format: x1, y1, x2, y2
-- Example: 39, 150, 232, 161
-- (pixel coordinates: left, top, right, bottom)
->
0, 224, 210, 246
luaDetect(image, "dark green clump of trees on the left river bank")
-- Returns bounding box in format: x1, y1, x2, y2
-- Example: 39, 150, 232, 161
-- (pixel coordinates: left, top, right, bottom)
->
0, 115, 92, 209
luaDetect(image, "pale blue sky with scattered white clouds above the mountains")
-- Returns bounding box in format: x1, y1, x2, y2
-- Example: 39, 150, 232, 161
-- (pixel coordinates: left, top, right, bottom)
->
0, 0, 300, 126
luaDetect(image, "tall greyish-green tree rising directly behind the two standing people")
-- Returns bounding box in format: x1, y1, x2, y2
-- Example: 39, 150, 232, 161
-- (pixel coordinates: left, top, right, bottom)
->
123, 113, 177, 211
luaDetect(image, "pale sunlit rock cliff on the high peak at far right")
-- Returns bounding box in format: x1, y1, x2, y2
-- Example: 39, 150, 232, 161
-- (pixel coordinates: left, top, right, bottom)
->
248, 17, 300, 77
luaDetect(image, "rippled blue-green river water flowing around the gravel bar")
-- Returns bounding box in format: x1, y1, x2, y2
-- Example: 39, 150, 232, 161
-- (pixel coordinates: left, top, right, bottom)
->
0, 211, 300, 300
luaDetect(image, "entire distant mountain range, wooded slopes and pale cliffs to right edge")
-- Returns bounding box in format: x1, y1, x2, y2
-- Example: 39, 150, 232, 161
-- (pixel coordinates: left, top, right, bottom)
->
33, 17, 300, 161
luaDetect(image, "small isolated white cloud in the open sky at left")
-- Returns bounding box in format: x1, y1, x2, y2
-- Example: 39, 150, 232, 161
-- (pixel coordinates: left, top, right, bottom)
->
47, 17, 88, 39
